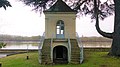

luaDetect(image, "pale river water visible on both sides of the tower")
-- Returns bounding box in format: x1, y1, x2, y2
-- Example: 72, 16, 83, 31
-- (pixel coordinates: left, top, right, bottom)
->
2, 42, 112, 49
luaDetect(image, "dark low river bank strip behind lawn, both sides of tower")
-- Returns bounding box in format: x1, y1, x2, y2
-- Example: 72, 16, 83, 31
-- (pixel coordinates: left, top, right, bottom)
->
0, 47, 110, 58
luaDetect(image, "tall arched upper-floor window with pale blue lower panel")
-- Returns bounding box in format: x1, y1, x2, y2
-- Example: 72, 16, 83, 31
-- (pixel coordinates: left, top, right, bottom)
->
56, 20, 64, 38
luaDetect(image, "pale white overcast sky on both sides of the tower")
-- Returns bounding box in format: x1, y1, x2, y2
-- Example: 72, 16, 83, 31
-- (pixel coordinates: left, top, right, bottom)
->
0, 0, 114, 36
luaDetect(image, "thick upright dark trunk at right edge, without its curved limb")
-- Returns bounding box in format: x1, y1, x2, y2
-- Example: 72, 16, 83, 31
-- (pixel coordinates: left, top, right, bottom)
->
109, 0, 120, 56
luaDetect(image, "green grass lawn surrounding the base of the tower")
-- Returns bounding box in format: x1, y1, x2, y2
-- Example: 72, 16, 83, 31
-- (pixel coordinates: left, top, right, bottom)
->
0, 51, 120, 67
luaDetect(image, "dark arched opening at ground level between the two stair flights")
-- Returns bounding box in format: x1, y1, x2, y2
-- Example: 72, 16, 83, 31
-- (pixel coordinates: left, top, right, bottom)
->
53, 46, 68, 64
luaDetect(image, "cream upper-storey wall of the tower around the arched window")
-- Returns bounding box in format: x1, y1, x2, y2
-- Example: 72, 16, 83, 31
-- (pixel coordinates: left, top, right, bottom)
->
45, 12, 76, 39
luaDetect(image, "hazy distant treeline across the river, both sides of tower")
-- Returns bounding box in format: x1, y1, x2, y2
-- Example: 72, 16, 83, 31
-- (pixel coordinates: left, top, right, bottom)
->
0, 35, 112, 42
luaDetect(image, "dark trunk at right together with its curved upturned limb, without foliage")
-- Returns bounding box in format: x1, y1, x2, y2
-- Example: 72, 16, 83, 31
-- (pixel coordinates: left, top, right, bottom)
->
94, 0, 120, 57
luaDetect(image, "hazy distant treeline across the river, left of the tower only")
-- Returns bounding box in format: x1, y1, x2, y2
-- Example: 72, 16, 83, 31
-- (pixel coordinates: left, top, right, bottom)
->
0, 35, 41, 41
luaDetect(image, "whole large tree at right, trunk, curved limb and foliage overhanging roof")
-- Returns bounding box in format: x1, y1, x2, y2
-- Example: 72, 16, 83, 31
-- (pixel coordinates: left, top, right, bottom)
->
20, 0, 120, 56
